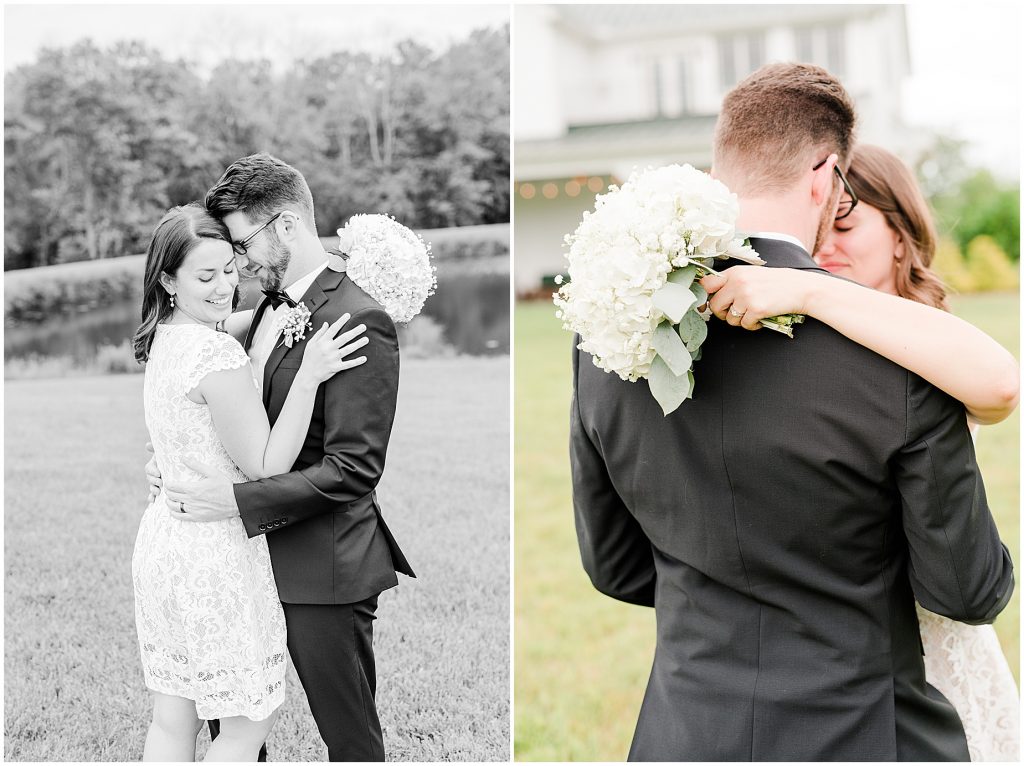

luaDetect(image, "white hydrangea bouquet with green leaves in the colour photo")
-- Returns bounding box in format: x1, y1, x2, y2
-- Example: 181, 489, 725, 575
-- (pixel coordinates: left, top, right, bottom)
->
554, 165, 803, 415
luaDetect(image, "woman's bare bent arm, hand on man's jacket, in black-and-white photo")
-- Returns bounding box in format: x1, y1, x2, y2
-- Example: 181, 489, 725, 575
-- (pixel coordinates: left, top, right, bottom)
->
190, 314, 367, 478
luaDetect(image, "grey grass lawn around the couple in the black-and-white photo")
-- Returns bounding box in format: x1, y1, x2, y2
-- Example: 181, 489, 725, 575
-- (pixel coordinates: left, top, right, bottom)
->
4, 357, 509, 761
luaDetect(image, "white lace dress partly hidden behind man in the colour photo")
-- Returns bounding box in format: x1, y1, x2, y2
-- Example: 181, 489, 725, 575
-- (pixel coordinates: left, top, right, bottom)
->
918, 605, 1020, 762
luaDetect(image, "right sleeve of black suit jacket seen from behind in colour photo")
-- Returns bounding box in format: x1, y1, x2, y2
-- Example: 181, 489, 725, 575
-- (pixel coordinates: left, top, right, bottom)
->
894, 374, 1014, 625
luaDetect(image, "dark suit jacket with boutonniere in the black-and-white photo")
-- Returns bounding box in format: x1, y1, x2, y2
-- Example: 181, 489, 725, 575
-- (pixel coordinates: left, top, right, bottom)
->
234, 257, 415, 604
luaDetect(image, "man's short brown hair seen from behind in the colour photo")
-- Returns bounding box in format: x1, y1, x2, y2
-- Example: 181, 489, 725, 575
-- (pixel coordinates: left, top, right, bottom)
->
714, 62, 856, 195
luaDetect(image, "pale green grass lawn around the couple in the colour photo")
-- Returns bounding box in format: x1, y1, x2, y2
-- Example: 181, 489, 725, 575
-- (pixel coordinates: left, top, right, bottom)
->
514, 293, 1020, 761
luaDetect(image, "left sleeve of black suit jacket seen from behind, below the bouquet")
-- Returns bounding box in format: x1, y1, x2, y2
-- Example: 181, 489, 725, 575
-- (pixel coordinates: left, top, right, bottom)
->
569, 337, 655, 606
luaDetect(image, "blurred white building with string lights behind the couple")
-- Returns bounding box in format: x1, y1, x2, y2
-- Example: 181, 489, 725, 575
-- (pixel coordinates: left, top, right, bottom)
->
513, 4, 912, 295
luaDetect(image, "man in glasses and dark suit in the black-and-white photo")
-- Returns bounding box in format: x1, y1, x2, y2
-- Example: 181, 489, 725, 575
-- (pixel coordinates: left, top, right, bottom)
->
155, 154, 415, 761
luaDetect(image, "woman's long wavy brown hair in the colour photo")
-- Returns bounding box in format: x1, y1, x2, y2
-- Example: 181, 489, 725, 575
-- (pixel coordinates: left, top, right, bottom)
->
848, 143, 949, 311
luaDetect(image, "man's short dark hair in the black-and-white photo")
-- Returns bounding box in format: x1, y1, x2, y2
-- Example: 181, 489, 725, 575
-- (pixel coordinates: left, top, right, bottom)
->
206, 152, 316, 233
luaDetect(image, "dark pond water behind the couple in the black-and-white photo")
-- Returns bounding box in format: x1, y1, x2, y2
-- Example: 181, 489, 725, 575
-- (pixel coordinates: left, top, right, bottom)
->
4, 271, 511, 364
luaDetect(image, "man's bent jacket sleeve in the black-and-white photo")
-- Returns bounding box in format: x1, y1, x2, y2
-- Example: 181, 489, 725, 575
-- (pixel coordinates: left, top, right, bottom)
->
234, 307, 398, 537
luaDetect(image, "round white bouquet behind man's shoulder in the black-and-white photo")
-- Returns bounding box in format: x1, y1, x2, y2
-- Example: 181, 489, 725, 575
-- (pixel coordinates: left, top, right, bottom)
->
338, 214, 437, 324
